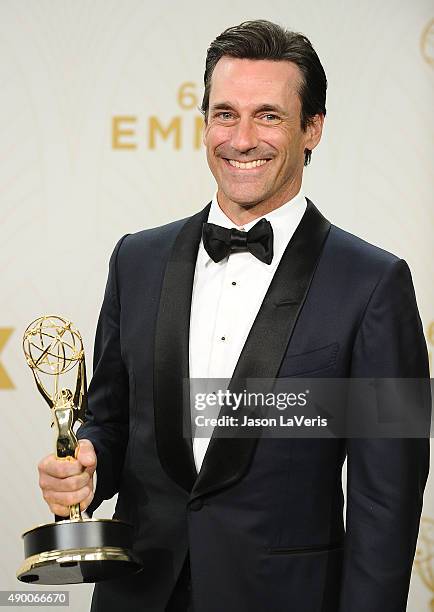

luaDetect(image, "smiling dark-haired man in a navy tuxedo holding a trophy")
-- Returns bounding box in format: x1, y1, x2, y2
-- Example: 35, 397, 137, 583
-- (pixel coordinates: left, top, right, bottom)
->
39, 21, 429, 612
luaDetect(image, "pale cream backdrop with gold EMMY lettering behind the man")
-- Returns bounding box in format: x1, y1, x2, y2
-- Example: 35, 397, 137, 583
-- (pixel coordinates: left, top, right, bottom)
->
0, 0, 434, 612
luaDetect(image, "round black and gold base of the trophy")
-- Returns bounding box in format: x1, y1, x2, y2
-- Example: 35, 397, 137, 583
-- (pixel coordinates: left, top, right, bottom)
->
17, 519, 142, 584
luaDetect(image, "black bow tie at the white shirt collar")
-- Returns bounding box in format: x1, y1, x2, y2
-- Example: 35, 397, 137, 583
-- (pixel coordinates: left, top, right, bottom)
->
202, 219, 273, 264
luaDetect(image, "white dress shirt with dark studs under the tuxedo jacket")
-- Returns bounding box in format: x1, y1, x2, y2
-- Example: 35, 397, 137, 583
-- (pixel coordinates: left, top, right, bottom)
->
189, 190, 307, 472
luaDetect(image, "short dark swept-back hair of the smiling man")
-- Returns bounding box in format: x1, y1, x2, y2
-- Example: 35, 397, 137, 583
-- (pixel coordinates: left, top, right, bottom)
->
201, 19, 327, 166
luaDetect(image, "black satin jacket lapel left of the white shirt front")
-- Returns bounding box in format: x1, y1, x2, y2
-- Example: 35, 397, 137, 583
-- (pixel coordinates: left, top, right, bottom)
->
154, 205, 209, 491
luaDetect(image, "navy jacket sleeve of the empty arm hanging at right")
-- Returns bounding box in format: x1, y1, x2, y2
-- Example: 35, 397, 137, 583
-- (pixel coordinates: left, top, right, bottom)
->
339, 259, 430, 612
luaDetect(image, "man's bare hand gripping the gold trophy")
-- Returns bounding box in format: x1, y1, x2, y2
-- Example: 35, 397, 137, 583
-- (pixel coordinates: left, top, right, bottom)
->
38, 440, 96, 517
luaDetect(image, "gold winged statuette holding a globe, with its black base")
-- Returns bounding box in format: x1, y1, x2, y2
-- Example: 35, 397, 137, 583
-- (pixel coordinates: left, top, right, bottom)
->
17, 316, 142, 584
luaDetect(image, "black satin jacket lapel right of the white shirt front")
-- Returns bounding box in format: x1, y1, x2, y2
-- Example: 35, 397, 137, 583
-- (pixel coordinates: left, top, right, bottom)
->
192, 200, 330, 498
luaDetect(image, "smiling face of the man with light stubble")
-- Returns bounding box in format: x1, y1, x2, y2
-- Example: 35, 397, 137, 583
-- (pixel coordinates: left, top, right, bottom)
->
204, 56, 322, 210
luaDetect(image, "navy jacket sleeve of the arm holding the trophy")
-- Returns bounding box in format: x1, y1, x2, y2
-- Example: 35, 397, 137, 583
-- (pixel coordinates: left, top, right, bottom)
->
77, 236, 129, 516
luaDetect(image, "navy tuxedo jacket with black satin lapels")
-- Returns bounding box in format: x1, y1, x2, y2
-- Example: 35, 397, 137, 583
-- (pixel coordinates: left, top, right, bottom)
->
79, 201, 429, 612
